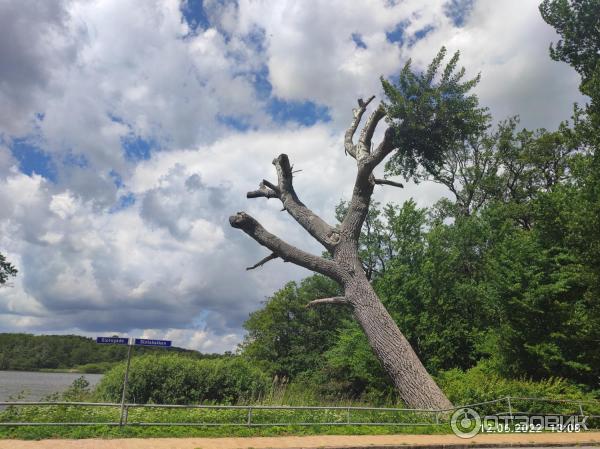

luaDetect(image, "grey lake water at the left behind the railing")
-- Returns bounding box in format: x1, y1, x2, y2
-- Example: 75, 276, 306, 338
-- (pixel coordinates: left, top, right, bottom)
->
0, 371, 102, 401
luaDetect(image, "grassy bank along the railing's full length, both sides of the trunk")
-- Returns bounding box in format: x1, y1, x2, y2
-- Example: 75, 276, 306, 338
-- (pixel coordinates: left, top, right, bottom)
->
0, 400, 600, 439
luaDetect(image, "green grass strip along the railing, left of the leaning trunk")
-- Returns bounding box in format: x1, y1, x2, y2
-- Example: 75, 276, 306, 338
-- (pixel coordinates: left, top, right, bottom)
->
0, 406, 450, 439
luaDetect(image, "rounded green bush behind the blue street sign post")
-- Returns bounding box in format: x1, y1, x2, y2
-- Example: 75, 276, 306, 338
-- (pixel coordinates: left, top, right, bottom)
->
95, 354, 270, 404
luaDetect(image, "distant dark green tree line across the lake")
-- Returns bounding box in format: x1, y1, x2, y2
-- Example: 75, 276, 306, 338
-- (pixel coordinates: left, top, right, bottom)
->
0, 334, 218, 372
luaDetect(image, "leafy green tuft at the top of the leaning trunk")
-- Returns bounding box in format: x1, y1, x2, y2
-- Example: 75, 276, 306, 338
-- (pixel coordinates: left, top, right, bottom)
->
381, 47, 490, 188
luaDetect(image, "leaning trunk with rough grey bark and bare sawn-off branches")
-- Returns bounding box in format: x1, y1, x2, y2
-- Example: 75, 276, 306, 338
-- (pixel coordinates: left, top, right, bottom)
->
229, 97, 452, 409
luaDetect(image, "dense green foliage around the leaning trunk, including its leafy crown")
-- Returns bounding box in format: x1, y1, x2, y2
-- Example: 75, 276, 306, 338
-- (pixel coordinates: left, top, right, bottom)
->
242, 0, 600, 403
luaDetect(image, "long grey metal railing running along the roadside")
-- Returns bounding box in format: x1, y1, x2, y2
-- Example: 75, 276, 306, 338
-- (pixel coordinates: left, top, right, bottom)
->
0, 396, 600, 427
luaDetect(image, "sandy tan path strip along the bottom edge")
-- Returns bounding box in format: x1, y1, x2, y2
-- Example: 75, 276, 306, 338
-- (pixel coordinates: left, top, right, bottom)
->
0, 432, 600, 449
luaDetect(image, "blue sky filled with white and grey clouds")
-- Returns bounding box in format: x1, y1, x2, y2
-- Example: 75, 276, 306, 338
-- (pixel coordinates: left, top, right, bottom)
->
0, 0, 579, 352
